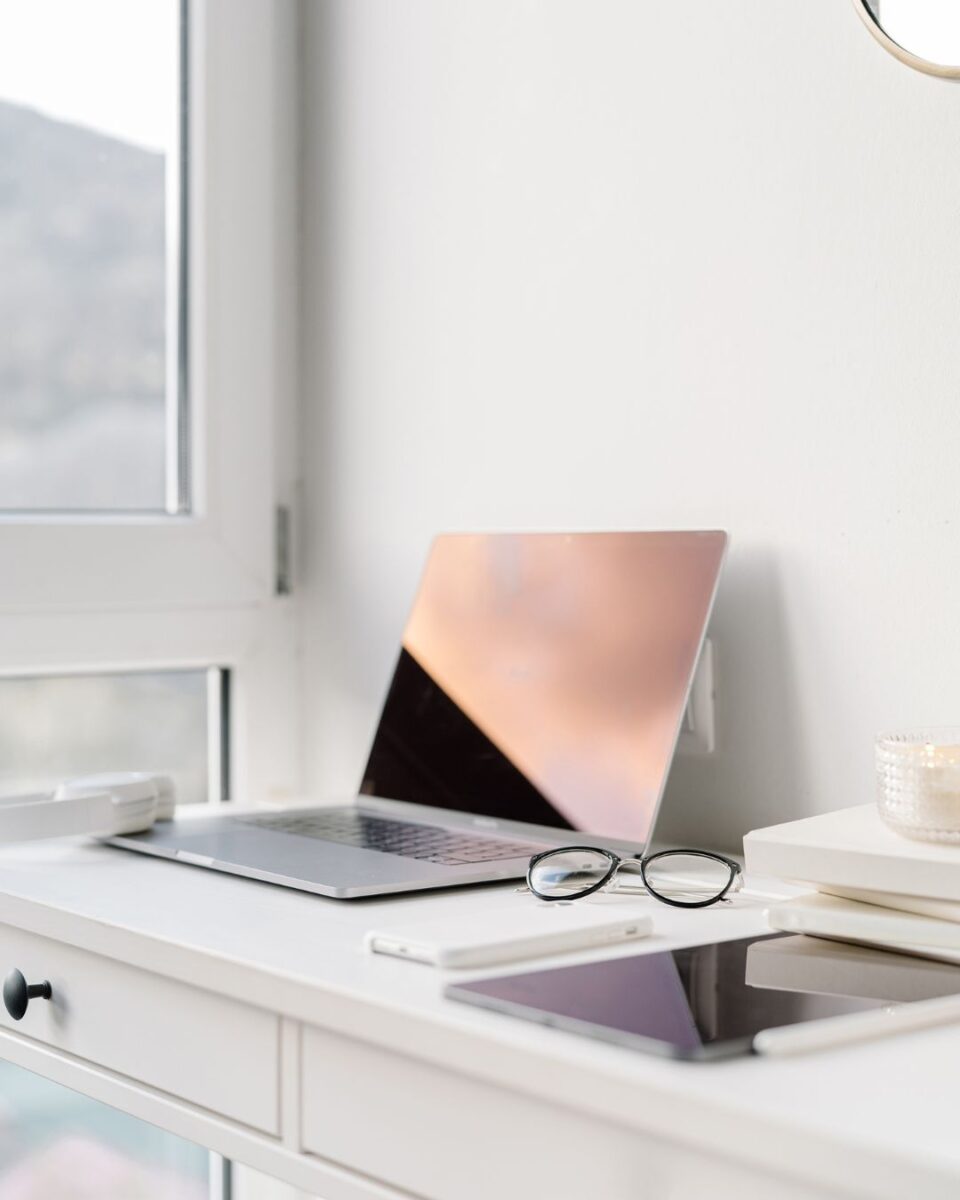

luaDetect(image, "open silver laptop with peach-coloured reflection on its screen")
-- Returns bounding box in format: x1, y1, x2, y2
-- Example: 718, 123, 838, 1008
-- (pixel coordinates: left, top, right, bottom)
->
110, 532, 727, 899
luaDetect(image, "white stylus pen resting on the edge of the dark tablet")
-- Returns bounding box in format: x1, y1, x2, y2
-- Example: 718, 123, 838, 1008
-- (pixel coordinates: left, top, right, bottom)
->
754, 996, 960, 1055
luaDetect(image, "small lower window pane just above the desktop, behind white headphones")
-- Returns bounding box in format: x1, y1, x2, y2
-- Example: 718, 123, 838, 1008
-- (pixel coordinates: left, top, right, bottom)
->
0, 671, 211, 806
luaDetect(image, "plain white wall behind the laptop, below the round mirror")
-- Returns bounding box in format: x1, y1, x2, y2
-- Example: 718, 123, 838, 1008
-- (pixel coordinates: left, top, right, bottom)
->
304, 0, 960, 845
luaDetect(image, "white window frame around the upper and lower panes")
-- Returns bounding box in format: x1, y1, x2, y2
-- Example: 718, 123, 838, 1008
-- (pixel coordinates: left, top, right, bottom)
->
0, 0, 300, 800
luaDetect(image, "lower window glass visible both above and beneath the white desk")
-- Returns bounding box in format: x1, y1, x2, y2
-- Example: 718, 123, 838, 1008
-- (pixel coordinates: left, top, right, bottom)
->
0, 671, 226, 1200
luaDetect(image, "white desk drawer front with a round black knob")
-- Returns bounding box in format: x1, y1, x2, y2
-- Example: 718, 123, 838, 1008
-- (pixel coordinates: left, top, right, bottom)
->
0, 925, 280, 1135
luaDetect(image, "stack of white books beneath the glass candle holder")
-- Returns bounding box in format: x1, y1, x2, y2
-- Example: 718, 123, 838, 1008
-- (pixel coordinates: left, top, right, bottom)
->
744, 804, 960, 962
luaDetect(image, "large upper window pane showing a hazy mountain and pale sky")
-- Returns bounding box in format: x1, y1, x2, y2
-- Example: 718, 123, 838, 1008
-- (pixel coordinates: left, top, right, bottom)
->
0, 0, 185, 511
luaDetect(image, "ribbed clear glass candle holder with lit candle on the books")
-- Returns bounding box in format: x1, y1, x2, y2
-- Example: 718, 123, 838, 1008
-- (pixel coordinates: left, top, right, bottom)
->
876, 726, 960, 845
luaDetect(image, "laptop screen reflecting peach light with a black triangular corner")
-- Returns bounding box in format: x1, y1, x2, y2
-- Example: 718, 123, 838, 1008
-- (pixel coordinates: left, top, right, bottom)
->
361, 532, 726, 844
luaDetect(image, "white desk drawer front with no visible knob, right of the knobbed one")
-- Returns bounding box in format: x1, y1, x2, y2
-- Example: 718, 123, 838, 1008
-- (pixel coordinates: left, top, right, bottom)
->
302, 1027, 835, 1200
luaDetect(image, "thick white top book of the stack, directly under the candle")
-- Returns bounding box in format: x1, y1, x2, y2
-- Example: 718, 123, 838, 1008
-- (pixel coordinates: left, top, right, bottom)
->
743, 804, 960, 916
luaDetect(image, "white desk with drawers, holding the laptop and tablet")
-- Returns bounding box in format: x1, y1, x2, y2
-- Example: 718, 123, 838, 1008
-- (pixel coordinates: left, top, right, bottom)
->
0, 844, 960, 1200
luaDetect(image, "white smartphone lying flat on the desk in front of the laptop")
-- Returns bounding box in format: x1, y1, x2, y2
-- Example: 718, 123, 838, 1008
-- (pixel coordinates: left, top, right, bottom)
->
365, 895, 653, 967
